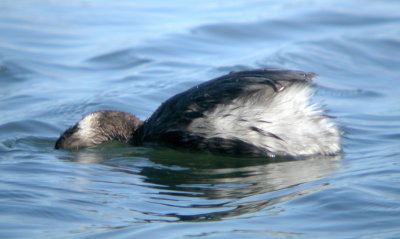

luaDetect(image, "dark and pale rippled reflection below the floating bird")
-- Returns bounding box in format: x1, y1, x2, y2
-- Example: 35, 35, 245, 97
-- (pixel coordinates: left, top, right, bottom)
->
70, 148, 340, 221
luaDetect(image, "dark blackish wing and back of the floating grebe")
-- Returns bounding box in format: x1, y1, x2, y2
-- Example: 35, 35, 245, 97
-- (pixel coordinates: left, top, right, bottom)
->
139, 69, 315, 147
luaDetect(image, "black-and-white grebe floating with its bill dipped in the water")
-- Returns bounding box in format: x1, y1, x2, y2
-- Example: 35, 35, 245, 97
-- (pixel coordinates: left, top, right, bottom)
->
55, 69, 341, 157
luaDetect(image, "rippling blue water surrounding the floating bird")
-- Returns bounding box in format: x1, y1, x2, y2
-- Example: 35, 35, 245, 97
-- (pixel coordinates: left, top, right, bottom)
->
0, 0, 400, 239
